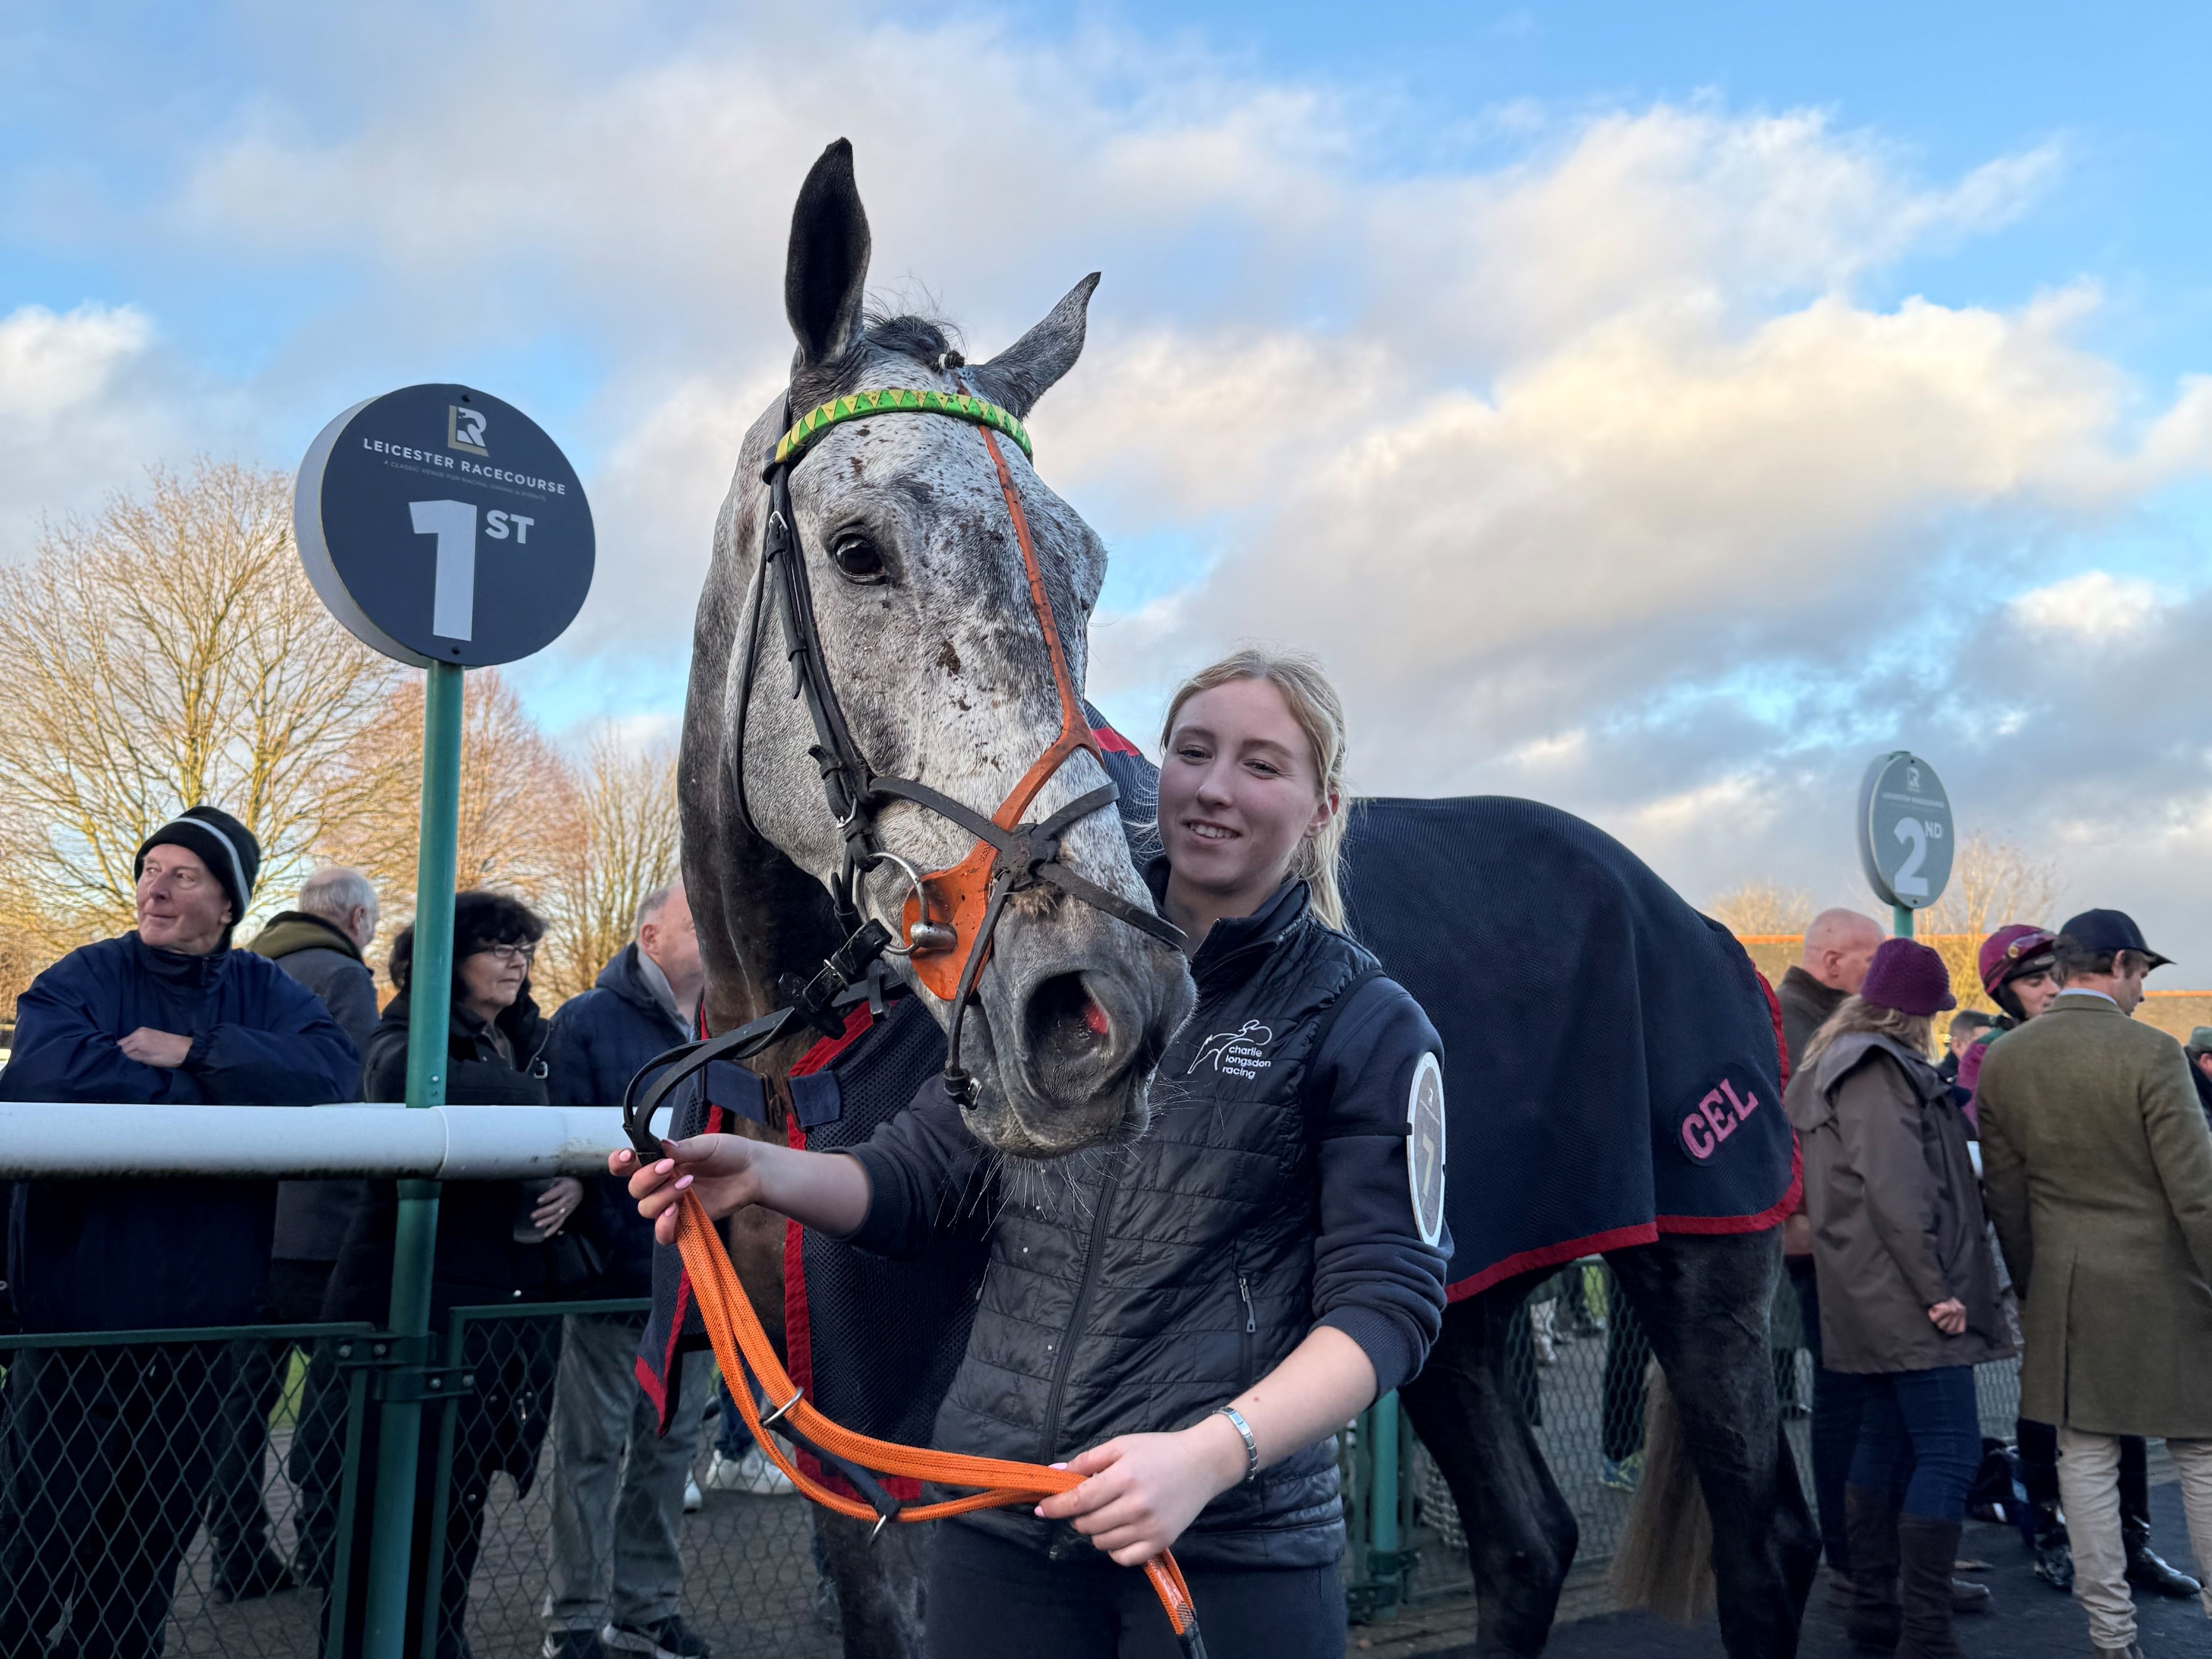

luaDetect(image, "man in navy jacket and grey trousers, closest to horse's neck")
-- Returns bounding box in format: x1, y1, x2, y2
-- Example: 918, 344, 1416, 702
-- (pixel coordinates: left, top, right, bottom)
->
544, 885, 715, 1659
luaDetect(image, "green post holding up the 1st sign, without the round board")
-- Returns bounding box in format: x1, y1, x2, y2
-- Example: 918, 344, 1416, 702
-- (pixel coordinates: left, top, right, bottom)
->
363, 661, 462, 1659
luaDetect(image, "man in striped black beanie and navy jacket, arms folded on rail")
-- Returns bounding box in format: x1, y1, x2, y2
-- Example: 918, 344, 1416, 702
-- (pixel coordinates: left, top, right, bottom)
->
0, 808, 360, 1654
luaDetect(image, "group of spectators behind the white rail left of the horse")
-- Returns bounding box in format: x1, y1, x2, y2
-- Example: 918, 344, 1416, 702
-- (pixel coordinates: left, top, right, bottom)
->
0, 808, 789, 1659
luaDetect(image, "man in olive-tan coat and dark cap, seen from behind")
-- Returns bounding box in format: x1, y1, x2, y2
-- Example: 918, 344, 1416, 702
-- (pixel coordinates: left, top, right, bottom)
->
1978, 911, 2212, 1657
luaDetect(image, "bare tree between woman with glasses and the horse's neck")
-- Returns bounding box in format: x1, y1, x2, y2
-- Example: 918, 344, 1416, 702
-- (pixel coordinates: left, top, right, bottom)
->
538, 730, 681, 1002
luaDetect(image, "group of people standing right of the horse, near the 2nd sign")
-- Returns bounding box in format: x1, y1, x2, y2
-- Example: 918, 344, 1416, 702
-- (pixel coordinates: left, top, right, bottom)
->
1776, 909, 2212, 1659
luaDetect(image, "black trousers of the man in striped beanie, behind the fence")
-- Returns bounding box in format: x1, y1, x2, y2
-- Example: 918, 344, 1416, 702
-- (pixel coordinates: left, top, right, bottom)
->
0, 1342, 230, 1659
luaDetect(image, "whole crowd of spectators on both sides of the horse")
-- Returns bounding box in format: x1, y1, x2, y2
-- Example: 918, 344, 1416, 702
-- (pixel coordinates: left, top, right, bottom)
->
0, 808, 2212, 1659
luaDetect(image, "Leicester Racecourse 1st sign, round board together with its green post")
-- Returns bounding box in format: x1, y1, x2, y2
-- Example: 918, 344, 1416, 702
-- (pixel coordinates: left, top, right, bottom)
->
292, 385, 593, 1659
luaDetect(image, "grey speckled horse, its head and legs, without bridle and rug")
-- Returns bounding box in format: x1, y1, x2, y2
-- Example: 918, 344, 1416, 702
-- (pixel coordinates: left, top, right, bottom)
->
679, 141, 1814, 1659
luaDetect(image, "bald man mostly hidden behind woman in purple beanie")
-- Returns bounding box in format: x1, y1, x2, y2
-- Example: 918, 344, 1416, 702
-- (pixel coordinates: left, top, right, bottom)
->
1774, 909, 1883, 1599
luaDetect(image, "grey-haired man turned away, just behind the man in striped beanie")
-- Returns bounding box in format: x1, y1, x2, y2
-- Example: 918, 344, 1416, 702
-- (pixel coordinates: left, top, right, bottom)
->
208, 865, 376, 1602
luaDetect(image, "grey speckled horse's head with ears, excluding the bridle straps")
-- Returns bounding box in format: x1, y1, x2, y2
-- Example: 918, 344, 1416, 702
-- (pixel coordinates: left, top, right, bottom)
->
684, 141, 1192, 1157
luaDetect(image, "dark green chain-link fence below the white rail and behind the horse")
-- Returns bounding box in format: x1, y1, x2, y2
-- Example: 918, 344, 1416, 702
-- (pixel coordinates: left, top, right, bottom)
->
0, 1261, 2019, 1659
